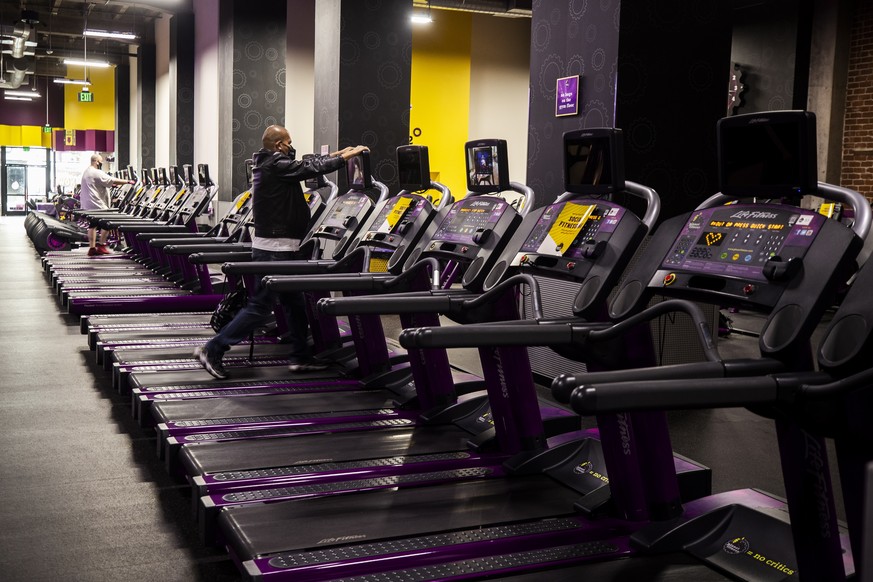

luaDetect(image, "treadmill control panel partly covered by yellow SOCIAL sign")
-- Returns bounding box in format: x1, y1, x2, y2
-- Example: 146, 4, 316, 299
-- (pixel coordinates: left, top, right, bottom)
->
521, 200, 626, 259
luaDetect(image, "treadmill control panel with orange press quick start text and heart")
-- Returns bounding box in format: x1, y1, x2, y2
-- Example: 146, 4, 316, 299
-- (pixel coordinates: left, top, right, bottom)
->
662, 204, 827, 281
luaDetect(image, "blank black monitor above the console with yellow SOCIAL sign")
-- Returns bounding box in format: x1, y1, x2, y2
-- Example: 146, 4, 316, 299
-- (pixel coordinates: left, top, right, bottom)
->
564, 127, 624, 195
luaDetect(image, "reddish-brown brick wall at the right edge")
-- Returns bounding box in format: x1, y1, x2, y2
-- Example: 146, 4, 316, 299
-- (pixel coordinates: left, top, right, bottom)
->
840, 0, 873, 199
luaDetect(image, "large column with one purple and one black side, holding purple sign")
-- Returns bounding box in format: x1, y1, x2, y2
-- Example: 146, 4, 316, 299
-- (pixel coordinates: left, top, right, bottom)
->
528, 0, 730, 218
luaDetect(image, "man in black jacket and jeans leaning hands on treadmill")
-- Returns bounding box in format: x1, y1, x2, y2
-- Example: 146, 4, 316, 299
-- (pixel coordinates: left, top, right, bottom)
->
194, 125, 367, 378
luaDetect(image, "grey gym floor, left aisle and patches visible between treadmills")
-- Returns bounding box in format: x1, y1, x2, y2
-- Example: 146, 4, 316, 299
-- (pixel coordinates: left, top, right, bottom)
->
0, 217, 843, 582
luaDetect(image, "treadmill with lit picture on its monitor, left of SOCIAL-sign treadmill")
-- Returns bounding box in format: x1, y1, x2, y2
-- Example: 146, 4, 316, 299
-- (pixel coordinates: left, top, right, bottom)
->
141, 140, 533, 463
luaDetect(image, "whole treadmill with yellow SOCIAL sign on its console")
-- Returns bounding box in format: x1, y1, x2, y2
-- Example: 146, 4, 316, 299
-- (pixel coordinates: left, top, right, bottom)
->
180, 129, 709, 536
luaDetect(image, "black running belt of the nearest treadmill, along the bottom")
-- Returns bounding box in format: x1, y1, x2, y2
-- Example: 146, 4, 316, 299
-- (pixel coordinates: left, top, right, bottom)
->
219, 475, 579, 560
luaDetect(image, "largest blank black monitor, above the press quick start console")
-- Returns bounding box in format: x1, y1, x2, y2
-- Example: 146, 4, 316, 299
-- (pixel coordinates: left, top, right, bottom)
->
718, 111, 817, 198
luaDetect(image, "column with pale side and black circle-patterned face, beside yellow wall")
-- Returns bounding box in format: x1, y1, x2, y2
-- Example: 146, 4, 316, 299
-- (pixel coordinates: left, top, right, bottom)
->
315, 0, 412, 189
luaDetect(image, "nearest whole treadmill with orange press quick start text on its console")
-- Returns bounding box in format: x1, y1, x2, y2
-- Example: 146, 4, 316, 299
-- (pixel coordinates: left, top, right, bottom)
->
218, 112, 869, 580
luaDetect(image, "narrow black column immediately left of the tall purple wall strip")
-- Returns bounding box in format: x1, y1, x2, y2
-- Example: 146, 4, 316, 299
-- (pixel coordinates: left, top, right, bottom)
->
170, 12, 194, 170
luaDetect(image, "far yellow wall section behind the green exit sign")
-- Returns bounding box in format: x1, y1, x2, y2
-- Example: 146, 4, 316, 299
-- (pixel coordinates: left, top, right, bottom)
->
64, 66, 115, 131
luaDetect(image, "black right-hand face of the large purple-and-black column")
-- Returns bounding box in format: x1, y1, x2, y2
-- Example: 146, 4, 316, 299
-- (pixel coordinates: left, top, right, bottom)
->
616, 0, 731, 220
